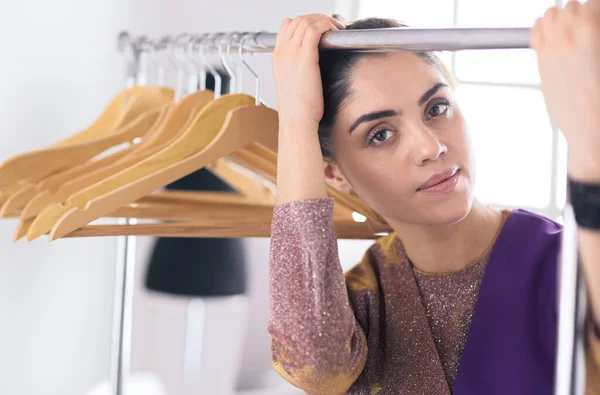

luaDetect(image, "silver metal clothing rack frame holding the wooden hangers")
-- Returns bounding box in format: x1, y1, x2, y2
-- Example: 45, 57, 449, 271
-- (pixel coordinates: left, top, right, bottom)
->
111, 27, 586, 395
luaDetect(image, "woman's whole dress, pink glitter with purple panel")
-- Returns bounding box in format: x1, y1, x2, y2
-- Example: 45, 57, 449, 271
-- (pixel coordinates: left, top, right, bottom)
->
269, 199, 600, 395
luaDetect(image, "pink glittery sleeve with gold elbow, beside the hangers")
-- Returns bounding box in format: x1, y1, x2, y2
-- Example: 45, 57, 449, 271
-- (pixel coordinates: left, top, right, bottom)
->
268, 199, 367, 395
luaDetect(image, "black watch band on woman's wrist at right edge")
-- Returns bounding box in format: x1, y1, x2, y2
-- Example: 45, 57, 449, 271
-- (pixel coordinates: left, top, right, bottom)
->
568, 178, 600, 230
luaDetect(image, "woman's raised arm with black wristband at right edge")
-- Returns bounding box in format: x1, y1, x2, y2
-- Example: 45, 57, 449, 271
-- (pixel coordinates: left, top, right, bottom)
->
531, 0, 600, 342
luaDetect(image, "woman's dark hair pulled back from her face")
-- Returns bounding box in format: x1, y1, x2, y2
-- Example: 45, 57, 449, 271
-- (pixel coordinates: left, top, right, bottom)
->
319, 18, 456, 162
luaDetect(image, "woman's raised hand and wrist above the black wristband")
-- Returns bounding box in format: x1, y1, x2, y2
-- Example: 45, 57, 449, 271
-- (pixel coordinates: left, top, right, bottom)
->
531, 0, 600, 182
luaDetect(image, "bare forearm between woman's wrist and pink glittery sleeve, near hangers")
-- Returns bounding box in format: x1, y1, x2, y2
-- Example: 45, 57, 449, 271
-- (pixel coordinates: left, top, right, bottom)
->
276, 120, 327, 205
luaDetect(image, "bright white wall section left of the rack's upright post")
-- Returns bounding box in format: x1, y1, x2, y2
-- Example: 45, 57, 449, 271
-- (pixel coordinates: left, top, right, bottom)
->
0, 0, 126, 395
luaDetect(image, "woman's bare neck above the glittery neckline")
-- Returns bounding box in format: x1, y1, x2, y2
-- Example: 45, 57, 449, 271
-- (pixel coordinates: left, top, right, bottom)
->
392, 199, 502, 273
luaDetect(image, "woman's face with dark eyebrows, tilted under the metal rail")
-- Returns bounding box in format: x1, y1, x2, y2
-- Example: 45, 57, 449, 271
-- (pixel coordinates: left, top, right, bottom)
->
326, 52, 474, 225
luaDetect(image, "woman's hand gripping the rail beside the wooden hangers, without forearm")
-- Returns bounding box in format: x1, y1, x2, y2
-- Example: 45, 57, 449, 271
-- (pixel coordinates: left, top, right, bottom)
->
271, 14, 344, 127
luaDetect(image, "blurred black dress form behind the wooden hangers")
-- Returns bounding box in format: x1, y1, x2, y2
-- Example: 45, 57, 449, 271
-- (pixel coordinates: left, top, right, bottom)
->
146, 73, 246, 297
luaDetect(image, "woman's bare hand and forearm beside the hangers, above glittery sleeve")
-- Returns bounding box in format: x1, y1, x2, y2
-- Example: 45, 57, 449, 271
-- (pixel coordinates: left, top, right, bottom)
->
271, 14, 344, 205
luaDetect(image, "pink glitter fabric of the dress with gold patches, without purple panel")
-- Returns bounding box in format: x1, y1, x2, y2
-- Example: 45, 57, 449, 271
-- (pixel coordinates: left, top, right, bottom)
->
268, 199, 600, 395
